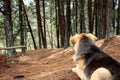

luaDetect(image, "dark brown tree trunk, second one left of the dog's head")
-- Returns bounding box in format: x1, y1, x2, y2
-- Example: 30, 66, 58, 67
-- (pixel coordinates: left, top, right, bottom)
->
58, 0, 65, 47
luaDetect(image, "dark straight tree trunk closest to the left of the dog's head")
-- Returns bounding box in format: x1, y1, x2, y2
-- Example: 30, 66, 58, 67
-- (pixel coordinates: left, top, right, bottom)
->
64, 0, 71, 48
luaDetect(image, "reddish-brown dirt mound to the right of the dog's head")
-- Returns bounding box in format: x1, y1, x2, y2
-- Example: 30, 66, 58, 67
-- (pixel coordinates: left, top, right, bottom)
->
101, 35, 120, 61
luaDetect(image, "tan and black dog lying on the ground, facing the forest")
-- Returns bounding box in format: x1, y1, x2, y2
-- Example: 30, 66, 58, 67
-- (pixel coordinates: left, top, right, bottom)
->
70, 33, 120, 80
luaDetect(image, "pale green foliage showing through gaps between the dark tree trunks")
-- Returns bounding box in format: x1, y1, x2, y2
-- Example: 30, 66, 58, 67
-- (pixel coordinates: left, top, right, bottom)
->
0, 0, 117, 48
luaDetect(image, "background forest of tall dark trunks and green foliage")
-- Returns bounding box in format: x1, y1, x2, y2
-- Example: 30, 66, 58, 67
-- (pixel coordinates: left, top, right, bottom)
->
0, 0, 120, 55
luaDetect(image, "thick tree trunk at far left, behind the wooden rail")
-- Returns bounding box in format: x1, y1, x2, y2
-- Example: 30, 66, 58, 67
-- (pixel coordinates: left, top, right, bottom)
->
4, 0, 15, 56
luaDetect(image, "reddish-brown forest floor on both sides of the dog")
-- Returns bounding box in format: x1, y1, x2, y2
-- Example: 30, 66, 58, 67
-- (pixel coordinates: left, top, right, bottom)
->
0, 36, 120, 80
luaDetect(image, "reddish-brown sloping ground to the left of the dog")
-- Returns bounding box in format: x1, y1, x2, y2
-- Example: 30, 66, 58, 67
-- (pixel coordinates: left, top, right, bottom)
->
0, 48, 80, 80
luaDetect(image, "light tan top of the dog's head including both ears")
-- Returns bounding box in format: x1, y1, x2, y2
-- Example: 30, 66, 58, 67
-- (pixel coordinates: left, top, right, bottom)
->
70, 33, 97, 45
